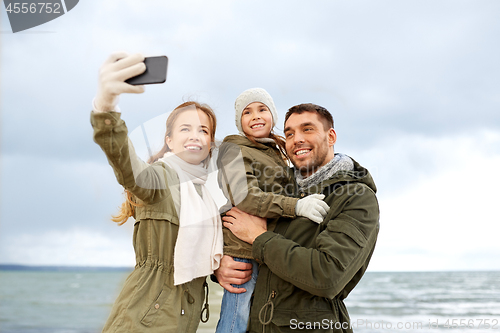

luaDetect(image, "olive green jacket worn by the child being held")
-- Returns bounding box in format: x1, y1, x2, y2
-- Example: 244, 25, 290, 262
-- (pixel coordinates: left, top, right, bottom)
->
217, 135, 298, 259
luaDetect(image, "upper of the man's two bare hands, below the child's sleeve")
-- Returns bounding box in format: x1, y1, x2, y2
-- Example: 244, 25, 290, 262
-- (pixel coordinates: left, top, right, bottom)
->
222, 207, 267, 244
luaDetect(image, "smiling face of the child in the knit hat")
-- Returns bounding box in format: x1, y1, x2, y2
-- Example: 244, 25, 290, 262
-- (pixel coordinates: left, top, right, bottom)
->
241, 102, 273, 138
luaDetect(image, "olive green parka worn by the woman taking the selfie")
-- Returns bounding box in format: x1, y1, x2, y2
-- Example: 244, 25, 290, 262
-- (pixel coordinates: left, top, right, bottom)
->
91, 112, 205, 333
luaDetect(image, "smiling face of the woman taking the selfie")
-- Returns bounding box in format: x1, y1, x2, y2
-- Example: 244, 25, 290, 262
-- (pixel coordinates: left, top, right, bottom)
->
165, 110, 211, 164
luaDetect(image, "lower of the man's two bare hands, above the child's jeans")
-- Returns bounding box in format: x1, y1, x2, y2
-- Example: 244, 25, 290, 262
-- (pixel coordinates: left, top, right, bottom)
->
214, 255, 252, 294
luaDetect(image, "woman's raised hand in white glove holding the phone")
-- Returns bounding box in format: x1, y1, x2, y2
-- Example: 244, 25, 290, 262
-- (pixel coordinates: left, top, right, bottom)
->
95, 52, 146, 112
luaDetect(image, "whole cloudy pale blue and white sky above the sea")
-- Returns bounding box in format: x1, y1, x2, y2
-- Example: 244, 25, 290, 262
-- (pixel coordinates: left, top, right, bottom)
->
0, 0, 500, 271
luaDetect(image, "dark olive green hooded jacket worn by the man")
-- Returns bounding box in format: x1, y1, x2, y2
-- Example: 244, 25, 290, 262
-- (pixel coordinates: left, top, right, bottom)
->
249, 161, 379, 332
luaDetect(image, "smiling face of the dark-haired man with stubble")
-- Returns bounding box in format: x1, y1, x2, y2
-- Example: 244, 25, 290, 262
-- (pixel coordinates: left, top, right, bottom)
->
284, 112, 337, 177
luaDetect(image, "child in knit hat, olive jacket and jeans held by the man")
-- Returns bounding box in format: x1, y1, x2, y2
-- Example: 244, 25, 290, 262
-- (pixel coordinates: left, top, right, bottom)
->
217, 88, 329, 333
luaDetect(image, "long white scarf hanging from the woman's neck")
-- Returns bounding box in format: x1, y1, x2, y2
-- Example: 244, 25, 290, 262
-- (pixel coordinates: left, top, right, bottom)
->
160, 152, 223, 285
